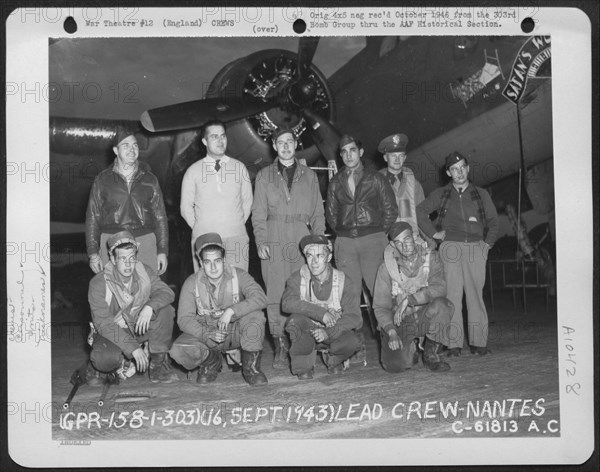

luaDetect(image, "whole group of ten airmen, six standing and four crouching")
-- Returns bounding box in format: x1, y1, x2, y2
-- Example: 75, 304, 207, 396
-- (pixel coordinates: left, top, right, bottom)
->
86, 121, 498, 386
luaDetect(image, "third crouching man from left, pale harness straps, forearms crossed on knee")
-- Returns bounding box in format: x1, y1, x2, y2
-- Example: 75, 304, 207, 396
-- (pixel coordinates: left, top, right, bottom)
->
281, 235, 362, 380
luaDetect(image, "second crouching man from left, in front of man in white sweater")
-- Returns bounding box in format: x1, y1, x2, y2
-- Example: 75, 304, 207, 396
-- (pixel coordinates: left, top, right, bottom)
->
170, 233, 267, 386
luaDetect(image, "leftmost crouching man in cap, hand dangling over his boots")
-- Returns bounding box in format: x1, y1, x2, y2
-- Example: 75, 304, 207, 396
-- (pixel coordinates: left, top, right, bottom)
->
88, 231, 177, 384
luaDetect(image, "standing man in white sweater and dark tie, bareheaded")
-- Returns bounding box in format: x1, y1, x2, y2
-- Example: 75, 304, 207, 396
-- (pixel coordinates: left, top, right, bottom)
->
180, 120, 252, 272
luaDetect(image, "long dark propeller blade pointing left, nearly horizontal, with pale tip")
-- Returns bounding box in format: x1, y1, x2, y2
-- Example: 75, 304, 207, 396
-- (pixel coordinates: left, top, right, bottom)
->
140, 97, 277, 132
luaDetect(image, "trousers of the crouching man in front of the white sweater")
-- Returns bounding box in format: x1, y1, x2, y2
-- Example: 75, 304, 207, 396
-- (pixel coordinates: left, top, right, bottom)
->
169, 311, 265, 370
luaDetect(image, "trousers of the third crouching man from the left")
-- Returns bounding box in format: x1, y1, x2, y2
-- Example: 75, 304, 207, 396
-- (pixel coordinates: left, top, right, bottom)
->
285, 314, 361, 375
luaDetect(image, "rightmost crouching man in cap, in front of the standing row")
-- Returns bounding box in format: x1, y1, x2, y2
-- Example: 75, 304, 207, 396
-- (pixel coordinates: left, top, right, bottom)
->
373, 221, 454, 372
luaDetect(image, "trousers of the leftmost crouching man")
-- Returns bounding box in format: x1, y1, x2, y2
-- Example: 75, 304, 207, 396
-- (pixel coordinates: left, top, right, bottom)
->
90, 305, 175, 372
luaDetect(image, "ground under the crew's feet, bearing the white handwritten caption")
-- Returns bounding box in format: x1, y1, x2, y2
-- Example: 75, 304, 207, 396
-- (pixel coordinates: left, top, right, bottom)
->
51, 265, 560, 441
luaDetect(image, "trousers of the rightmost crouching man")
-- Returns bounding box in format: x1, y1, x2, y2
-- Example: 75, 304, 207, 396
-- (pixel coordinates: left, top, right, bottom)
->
381, 297, 454, 372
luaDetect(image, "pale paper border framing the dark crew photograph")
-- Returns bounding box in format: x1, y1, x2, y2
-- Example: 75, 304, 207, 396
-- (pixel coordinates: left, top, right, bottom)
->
6, 7, 594, 467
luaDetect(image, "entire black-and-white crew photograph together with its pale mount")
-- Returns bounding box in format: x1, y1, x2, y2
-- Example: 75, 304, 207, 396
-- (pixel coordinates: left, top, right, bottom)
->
7, 7, 593, 466
